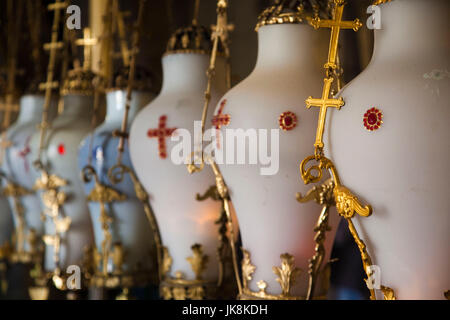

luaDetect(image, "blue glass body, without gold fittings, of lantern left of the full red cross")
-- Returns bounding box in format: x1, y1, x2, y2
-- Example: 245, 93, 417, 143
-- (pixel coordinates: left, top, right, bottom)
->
78, 90, 156, 274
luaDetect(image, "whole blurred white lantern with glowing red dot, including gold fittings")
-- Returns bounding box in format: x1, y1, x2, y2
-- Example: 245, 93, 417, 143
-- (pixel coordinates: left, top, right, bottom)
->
30, 68, 95, 289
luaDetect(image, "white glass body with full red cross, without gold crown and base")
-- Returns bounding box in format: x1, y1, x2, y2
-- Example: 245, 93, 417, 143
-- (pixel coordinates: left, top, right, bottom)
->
130, 53, 229, 281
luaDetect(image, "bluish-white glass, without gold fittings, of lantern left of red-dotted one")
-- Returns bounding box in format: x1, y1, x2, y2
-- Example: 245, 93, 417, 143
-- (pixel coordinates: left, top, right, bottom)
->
3, 94, 55, 251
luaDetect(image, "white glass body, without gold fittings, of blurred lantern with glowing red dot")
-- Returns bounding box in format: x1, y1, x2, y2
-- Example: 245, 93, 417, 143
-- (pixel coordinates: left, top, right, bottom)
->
31, 94, 93, 271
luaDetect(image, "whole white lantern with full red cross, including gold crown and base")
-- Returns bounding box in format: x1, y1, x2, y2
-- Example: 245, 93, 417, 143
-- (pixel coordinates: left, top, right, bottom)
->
130, 19, 230, 299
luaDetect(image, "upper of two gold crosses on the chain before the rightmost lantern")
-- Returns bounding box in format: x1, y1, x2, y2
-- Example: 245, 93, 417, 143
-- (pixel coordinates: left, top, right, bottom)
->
309, 0, 362, 69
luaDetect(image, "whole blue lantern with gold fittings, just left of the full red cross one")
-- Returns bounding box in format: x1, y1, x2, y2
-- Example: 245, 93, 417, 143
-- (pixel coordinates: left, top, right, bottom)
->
78, 68, 157, 288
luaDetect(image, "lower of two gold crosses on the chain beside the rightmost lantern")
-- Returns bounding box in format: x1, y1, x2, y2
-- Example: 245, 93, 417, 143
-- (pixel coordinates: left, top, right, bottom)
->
306, 77, 344, 149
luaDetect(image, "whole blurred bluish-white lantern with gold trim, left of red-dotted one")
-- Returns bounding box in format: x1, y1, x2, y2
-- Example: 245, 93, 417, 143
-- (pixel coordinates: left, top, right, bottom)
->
2, 93, 56, 263
